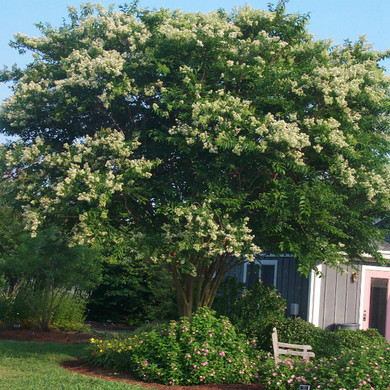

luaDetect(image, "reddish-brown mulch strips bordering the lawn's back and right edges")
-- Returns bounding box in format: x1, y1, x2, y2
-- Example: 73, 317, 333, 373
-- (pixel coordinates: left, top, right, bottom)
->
0, 325, 265, 390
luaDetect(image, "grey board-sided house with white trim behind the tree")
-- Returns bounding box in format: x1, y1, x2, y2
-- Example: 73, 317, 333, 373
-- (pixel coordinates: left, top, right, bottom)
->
229, 242, 390, 342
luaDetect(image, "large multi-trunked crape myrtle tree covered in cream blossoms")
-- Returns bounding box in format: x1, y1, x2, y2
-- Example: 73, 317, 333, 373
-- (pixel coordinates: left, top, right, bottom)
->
0, 2, 390, 316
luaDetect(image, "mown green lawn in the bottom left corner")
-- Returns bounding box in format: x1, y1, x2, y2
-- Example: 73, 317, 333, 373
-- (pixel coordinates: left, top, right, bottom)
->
0, 340, 149, 390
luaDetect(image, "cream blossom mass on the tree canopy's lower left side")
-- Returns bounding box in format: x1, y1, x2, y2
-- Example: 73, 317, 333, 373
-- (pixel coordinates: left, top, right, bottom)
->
7, 129, 153, 239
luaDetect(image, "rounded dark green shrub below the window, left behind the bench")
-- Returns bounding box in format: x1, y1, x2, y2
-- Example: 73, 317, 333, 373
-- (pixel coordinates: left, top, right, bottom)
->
230, 282, 286, 351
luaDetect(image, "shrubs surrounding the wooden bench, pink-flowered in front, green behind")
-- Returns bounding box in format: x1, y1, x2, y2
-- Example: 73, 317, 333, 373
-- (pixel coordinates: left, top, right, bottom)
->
260, 318, 390, 390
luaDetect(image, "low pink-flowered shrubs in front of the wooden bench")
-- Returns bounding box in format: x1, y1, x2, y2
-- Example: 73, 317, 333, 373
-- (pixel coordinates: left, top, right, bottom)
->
260, 346, 390, 390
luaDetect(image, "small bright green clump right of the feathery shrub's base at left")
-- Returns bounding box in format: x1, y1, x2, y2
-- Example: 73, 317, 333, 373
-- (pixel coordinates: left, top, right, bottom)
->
51, 294, 89, 332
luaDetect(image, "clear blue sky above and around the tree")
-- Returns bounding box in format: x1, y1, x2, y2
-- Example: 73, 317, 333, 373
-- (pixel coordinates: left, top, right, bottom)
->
0, 0, 390, 143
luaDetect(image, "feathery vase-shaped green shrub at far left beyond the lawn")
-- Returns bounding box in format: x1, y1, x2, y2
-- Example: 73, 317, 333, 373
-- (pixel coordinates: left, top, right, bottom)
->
0, 228, 100, 330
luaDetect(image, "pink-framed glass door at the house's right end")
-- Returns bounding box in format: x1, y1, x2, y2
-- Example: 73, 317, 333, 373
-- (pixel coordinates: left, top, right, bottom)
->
362, 269, 390, 341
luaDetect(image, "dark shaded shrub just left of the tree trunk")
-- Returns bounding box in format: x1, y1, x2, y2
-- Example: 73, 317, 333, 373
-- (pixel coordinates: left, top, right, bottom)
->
88, 259, 177, 325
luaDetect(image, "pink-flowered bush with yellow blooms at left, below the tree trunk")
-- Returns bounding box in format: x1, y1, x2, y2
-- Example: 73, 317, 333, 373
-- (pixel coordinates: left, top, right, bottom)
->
88, 308, 259, 385
